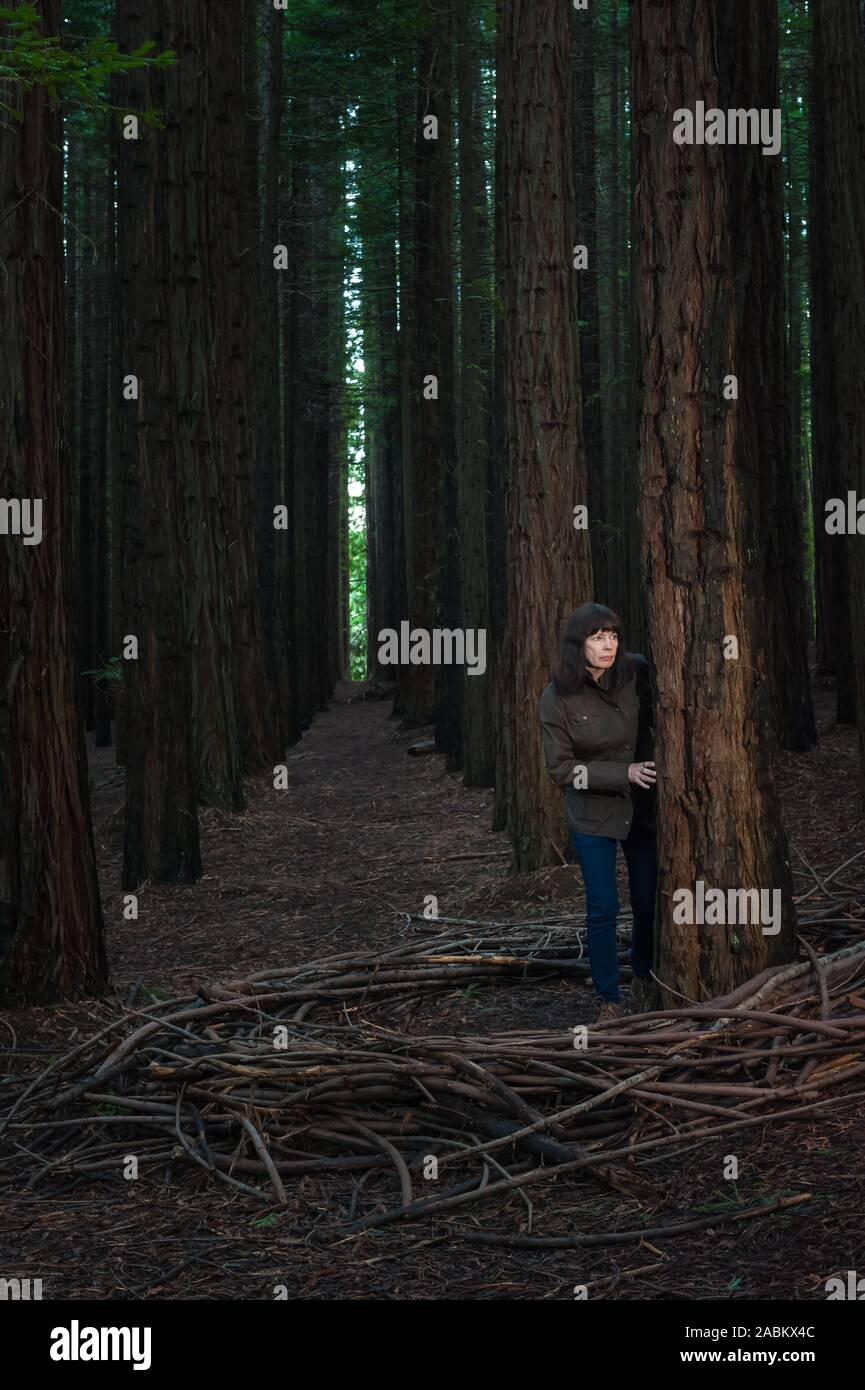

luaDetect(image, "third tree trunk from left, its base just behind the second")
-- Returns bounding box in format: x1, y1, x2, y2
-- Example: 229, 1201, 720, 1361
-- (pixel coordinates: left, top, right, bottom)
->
169, 0, 245, 810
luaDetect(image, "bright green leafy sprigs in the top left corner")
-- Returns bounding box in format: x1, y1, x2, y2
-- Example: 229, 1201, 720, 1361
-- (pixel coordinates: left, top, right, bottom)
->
0, 4, 177, 124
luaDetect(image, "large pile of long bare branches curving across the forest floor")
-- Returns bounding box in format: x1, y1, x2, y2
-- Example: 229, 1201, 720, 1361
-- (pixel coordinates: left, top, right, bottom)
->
0, 927, 865, 1245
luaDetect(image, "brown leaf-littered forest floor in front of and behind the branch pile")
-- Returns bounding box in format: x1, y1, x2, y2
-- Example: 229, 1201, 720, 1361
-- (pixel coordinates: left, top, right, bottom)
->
0, 685, 865, 1301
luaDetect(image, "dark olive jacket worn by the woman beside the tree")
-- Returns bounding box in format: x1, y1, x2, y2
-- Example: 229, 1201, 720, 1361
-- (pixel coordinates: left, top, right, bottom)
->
540, 652, 655, 840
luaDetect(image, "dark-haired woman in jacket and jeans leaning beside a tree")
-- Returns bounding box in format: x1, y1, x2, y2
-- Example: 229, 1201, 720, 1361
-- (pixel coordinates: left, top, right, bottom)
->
541, 603, 658, 1023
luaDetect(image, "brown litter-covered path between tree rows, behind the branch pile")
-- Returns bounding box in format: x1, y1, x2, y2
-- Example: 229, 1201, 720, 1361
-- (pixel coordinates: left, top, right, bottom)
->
92, 682, 603, 1027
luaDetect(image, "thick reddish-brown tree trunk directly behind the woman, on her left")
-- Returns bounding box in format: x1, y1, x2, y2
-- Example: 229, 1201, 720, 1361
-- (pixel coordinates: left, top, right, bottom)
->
499, 0, 591, 872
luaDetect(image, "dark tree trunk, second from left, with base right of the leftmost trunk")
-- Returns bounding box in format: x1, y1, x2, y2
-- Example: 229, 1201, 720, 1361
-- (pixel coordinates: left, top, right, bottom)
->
114, 0, 206, 888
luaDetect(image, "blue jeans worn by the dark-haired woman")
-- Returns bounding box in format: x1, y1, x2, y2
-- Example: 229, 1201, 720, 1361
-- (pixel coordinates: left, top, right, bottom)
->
570, 820, 658, 1004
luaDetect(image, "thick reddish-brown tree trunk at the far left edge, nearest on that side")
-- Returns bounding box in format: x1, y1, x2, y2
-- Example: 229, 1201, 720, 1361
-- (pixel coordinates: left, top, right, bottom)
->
0, 0, 108, 1005
